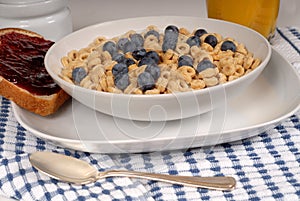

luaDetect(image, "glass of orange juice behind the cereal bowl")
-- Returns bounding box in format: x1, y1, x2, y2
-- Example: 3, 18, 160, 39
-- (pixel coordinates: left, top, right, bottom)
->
206, 0, 280, 40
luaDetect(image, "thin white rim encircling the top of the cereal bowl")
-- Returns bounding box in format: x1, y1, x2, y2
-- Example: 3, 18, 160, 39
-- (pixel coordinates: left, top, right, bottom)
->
44, 15, 272, 99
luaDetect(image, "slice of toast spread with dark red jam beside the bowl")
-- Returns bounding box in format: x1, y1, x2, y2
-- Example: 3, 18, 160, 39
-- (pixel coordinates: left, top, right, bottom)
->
0, 28, 69, 116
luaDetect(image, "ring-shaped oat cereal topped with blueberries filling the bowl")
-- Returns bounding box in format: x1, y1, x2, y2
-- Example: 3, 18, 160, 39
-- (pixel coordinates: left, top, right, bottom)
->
60, 25, 261, 94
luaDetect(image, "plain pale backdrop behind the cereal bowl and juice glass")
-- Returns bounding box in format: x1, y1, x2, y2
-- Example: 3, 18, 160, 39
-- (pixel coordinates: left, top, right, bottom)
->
70, 0, 300, 30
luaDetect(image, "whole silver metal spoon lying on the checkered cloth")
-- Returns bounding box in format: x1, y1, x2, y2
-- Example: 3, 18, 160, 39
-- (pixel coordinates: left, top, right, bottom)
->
29, 152, 236, 190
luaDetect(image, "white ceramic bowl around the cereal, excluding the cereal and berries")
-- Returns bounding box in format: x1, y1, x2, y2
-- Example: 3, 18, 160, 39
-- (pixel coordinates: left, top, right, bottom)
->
45, 16, 271, 121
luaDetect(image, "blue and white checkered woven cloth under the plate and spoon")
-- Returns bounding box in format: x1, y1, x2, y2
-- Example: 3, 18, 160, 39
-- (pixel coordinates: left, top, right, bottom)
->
0, 27, 300, 201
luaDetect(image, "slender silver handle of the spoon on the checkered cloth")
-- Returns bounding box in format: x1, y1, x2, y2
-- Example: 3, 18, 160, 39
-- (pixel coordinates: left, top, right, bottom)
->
98, 170, 236, 190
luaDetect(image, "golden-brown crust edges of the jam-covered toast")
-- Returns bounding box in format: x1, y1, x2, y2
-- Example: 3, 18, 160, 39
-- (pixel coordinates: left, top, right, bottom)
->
0, 28, 70, 116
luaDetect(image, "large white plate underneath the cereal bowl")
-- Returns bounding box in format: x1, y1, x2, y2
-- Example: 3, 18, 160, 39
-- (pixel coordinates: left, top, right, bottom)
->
13, 50, 300, 153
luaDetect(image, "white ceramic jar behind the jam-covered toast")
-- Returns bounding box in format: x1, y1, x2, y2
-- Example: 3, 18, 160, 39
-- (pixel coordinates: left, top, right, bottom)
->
0, 0, 73, 41
